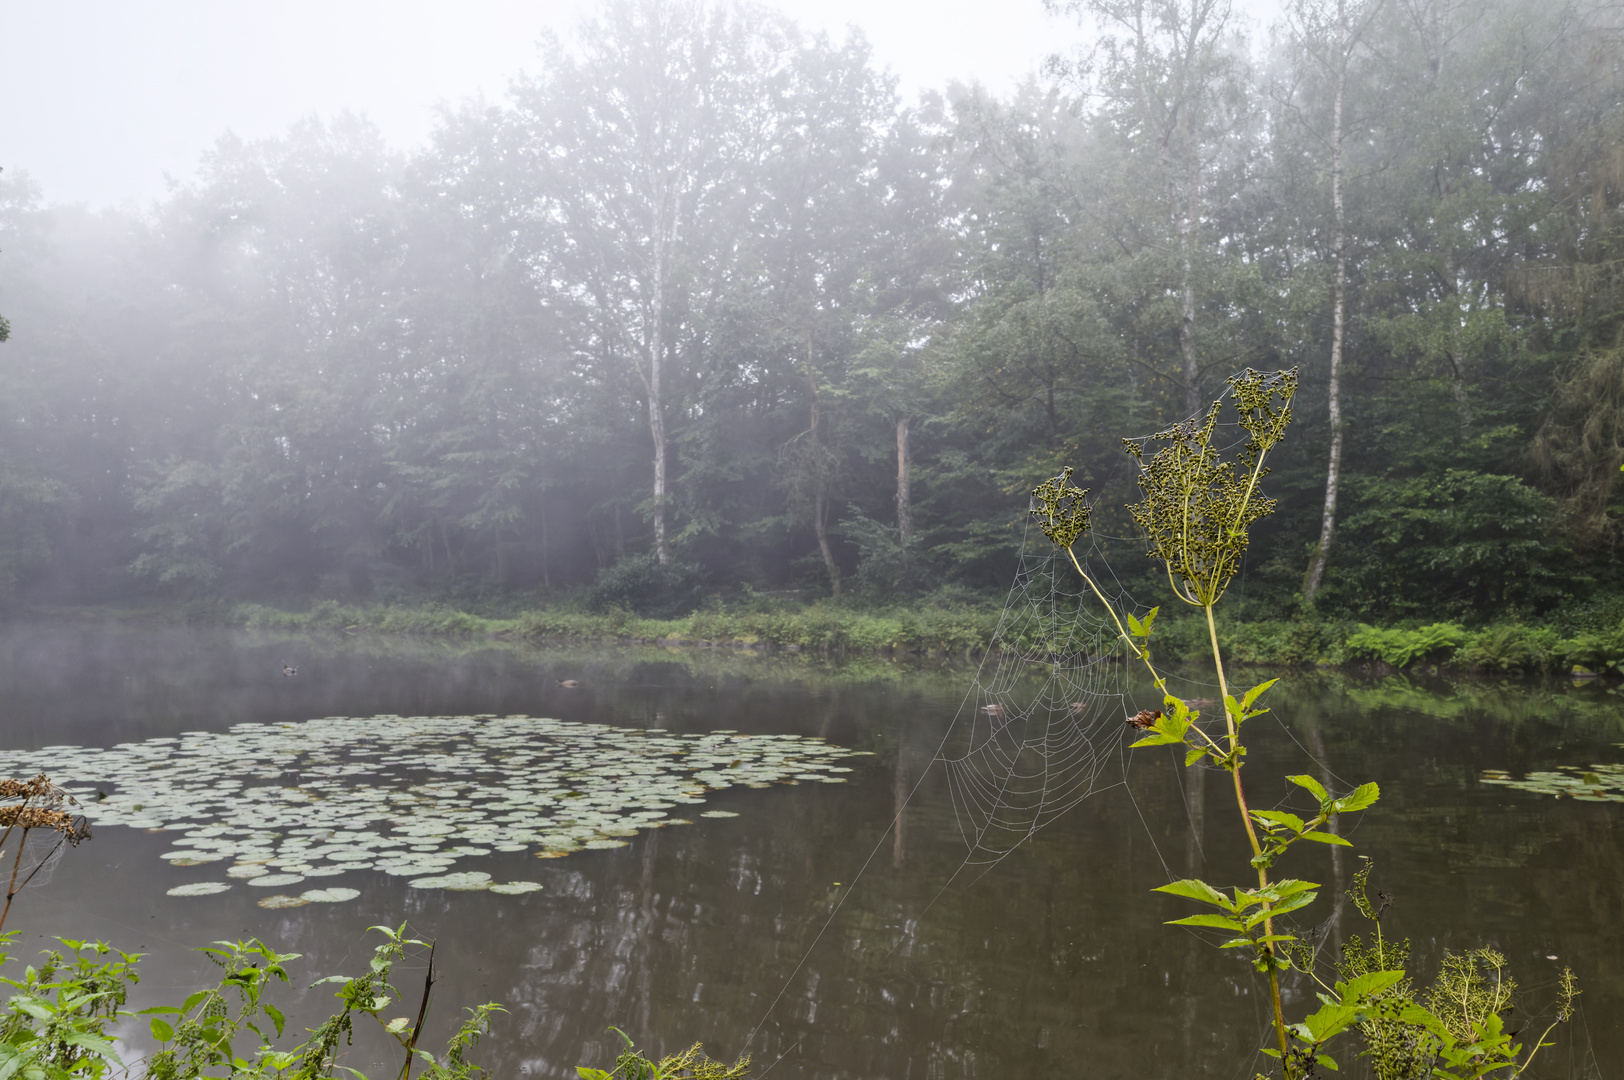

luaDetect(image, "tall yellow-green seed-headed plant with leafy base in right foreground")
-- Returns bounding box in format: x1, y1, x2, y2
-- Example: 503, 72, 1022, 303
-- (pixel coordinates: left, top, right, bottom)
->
1031, 369, 1577, 1080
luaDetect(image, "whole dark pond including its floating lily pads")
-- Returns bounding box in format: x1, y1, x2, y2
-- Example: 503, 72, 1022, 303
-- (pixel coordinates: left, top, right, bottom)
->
0, 624, 1624, 1080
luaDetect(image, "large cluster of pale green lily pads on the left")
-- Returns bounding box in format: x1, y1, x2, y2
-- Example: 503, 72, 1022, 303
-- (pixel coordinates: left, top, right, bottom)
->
0, 716, 856, 908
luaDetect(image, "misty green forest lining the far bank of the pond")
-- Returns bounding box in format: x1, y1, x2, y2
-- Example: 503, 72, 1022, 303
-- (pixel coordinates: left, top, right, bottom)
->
0, 0, 1624, 624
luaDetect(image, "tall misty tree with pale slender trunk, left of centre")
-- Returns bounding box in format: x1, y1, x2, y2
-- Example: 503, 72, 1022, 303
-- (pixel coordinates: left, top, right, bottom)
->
513, 0, 789, 564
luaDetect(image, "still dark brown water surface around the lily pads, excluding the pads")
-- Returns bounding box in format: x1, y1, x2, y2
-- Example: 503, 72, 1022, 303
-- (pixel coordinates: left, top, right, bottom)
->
0, 625, 1624, 1080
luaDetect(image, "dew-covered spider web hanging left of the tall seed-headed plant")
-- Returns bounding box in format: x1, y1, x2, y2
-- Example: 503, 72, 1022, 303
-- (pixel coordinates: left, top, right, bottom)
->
937, 531, 1135, 867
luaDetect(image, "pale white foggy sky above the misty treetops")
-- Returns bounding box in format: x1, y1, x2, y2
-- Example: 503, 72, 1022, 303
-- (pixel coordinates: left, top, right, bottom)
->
0, 0, 1263, 208
